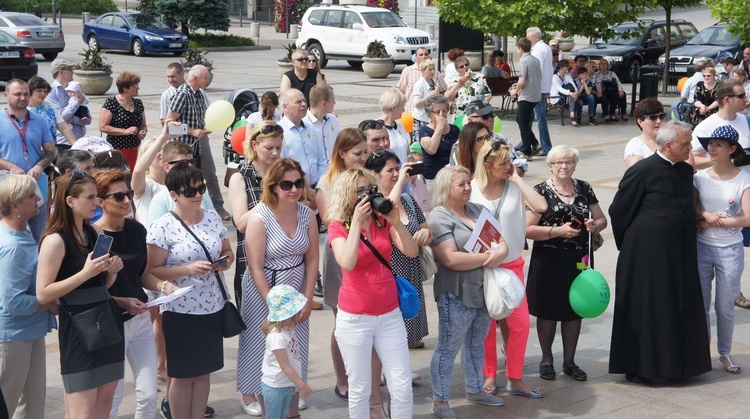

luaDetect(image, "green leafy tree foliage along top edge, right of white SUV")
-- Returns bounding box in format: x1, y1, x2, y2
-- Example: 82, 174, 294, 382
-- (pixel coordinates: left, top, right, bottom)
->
435, 0, 646, 38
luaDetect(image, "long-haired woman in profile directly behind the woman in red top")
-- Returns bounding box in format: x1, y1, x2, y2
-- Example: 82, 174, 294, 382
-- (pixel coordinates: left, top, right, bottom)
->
315, 128, 367, 400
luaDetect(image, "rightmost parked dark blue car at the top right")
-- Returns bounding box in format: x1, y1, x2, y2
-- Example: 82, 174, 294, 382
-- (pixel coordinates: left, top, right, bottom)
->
659, 22, 742, 77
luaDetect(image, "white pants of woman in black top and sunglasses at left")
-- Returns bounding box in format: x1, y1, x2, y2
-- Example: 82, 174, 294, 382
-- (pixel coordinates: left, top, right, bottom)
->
109, 311, 157, 419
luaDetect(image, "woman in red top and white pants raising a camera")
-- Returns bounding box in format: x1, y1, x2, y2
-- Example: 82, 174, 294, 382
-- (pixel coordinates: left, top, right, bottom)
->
328, 168, 418, 418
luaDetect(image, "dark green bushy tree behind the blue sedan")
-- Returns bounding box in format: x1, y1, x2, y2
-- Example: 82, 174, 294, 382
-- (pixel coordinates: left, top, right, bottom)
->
154, 0, 229, 35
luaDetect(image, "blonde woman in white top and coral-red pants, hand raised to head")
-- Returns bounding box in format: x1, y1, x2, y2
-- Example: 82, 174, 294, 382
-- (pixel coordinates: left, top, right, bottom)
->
471, 141, 547, 399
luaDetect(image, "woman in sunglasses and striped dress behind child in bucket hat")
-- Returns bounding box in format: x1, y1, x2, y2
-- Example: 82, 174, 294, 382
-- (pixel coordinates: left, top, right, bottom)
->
237, 158, 318, 418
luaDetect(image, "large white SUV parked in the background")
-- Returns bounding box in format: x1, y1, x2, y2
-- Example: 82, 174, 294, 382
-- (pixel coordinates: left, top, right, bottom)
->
296, 4, 437, 67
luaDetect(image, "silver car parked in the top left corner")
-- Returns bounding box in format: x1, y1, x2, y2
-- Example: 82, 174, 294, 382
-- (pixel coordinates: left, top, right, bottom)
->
0, 12, 65, 61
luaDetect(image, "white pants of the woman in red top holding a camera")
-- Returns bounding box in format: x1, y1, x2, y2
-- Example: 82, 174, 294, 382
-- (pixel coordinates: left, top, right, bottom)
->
335, 308, 414, 419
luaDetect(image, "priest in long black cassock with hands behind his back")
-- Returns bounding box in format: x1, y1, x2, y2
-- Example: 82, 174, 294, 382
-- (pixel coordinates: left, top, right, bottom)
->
609, 121, 711, 382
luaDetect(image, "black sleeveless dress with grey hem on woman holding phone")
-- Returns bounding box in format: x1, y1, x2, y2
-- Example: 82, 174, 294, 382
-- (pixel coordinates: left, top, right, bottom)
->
55, 226, 125, 393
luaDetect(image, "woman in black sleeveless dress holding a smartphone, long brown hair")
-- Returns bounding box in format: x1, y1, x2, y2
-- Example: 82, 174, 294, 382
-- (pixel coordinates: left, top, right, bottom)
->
36, 170, 125, 418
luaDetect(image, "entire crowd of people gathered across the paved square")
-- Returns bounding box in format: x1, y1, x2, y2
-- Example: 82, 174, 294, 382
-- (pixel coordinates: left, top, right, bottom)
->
0, 28, 750, 419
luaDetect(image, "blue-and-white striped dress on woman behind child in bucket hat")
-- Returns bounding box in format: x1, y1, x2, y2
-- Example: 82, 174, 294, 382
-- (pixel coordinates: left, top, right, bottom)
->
237, 203, 310, 394
